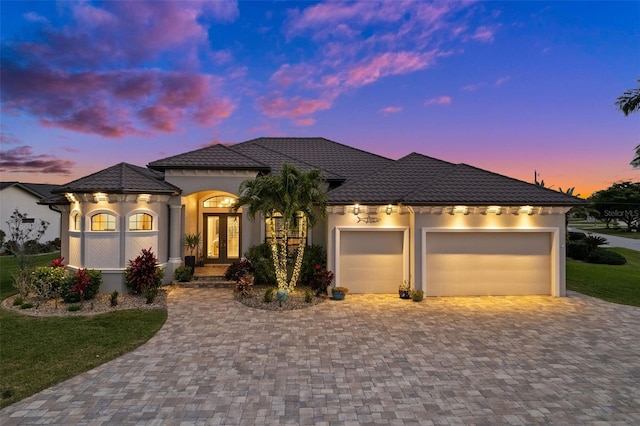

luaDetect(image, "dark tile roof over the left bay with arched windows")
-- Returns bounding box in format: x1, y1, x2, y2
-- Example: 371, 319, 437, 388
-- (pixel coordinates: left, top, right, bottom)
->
54, 163, 181, 194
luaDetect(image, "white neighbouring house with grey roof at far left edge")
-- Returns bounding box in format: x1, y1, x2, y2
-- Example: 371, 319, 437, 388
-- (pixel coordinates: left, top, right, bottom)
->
0, 182, 60, 248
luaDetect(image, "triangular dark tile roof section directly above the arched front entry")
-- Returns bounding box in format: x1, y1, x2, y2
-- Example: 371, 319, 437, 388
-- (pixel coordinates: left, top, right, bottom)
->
149, 144, 269, 171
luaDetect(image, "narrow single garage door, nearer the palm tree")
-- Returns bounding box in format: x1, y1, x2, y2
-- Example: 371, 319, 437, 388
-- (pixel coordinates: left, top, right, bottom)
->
338, 231, 404, 293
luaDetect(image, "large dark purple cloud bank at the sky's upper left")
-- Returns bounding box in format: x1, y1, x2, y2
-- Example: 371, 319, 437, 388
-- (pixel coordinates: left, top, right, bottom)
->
0, 1, 237, 137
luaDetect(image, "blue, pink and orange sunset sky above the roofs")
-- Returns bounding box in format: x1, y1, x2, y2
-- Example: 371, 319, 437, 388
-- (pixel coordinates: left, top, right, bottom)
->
0, 0, 640, 196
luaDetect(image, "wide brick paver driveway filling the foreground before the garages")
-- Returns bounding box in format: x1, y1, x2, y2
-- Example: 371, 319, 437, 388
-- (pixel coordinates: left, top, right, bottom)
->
0, 289, 640, 425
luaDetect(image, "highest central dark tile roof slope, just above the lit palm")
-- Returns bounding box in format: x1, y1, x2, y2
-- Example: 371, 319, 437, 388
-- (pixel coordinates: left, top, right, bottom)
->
231, 138, 393, 181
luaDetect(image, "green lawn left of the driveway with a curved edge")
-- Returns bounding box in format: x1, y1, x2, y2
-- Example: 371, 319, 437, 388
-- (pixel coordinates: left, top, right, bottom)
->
0, 253, 167, 407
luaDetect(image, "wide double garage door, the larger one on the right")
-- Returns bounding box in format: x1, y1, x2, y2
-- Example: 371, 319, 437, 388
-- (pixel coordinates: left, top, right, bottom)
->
425, 232, 552, 296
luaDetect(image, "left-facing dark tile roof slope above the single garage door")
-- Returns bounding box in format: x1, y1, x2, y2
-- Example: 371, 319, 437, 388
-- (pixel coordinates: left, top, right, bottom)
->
329, 152, 455, 204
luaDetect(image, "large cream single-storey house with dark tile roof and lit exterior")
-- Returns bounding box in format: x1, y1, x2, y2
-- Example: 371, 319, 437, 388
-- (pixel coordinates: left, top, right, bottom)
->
44, 138, 584, 296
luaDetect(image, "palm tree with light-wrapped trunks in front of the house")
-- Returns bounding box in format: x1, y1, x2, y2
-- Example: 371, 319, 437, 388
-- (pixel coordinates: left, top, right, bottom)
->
233, 163, 327, 291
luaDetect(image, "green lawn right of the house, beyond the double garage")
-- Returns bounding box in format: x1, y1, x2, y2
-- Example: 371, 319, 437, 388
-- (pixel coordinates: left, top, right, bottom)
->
567, 248, 640, 306
